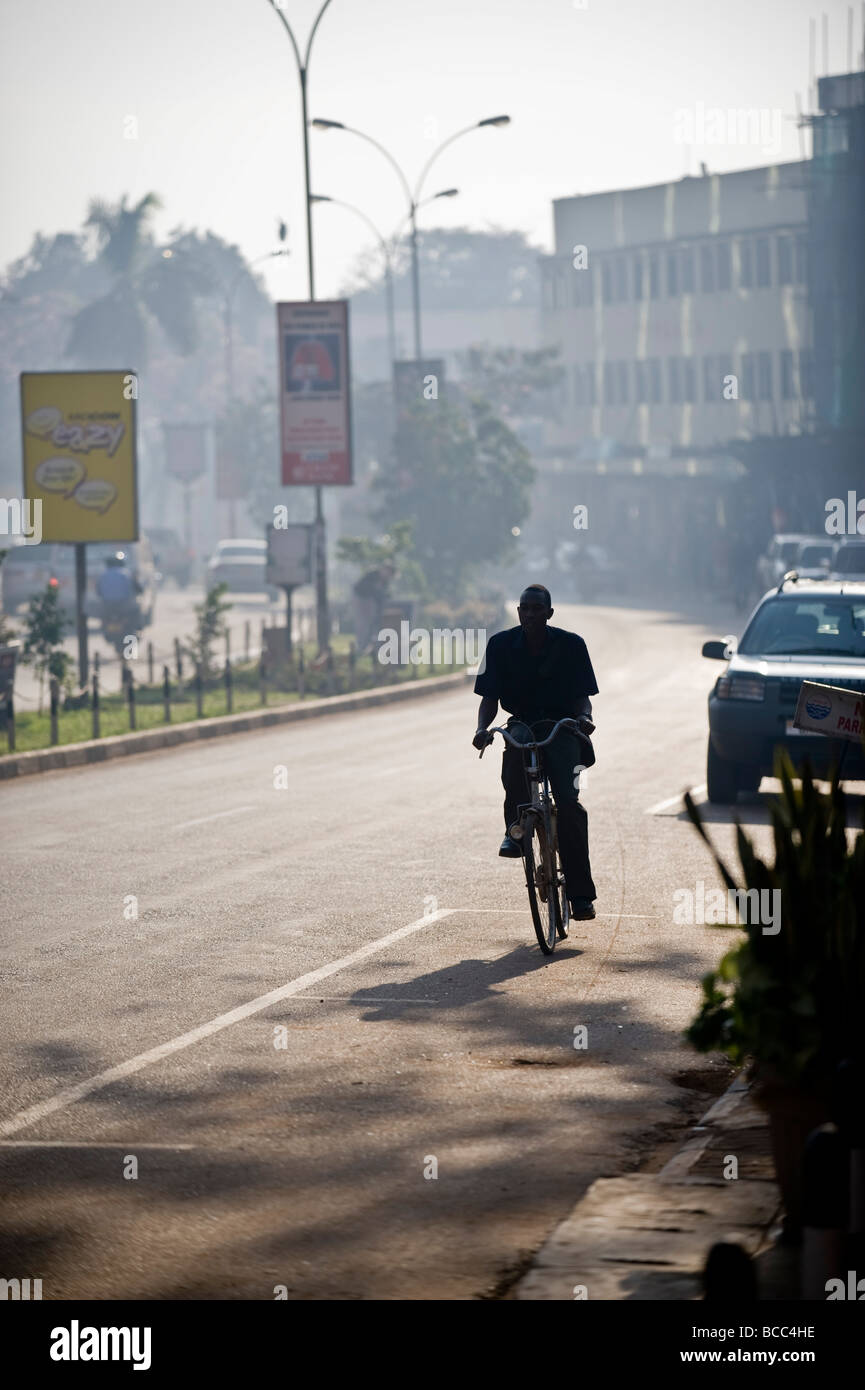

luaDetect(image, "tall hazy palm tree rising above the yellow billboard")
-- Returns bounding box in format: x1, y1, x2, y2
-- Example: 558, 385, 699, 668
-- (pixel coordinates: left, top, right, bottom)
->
67, 193, 211, 370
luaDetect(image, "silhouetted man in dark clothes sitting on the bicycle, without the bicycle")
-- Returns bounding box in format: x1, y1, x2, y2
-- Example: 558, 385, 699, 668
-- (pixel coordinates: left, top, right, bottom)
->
471, 584, 598, 922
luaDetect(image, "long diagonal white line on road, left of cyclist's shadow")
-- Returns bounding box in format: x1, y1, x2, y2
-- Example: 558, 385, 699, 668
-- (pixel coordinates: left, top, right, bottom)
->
0, 908, 455, 1136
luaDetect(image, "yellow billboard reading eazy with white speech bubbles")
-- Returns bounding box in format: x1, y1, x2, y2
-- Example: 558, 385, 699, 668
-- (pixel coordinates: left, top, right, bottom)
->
21, 371, 138, 542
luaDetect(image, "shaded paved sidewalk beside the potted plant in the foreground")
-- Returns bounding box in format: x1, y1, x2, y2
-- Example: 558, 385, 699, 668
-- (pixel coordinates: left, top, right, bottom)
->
512, 1079, 798, 1301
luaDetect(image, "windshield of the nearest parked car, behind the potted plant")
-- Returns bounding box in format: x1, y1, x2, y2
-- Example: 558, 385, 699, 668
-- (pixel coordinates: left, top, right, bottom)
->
738, 595, 865, 657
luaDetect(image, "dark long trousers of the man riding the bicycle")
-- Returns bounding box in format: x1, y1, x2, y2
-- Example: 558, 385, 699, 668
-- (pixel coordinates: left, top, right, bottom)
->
502, 719, 598, 902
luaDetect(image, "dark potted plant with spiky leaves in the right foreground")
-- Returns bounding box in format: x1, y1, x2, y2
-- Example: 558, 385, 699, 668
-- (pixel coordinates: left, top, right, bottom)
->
686, 751, 865, 1237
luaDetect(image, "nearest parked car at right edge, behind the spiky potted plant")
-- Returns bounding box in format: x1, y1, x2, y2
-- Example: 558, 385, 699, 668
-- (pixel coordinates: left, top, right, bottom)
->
702, 580, 865, 802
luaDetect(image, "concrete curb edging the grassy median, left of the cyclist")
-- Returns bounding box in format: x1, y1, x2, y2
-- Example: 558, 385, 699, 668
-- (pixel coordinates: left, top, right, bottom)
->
0, 670, 474, 781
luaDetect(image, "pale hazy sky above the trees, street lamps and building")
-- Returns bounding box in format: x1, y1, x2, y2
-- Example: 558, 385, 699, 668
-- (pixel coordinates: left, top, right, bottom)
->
0, 0, 865, 299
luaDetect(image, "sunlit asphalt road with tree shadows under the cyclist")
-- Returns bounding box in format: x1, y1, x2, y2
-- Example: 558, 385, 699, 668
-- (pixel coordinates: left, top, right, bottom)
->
0, 597, 856, 1300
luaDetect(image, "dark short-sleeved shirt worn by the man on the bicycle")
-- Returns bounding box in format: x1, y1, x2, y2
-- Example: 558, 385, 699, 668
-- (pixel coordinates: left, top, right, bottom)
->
474, 627, 598, 723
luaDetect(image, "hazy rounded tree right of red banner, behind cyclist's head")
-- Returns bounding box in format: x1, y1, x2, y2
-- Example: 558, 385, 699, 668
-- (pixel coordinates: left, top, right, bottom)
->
373, 398, 534, 600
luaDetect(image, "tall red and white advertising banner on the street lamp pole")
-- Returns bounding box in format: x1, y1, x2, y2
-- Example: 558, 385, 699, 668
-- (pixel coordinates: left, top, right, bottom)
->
277, 299, 352, 487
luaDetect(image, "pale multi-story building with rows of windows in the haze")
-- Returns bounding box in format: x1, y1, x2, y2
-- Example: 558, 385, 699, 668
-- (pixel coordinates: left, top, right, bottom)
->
533, 161, 814, 587
